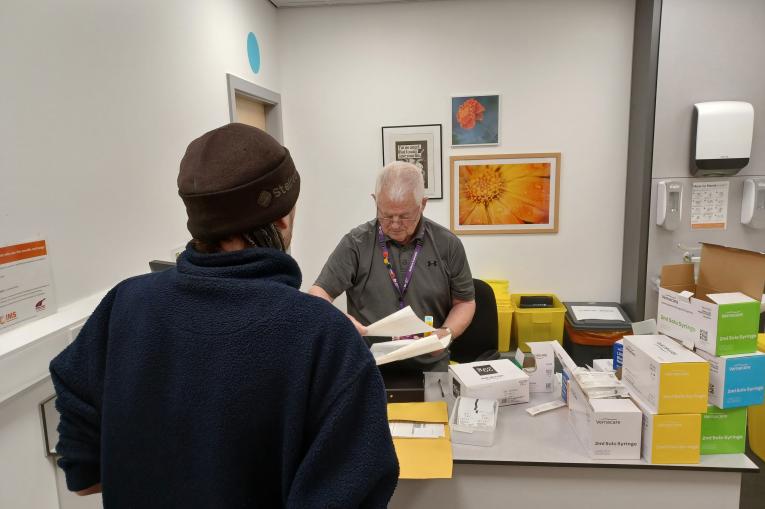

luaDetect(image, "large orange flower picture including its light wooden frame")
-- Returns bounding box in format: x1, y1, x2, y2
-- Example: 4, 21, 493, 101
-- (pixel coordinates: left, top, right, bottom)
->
449, 152, 560, 235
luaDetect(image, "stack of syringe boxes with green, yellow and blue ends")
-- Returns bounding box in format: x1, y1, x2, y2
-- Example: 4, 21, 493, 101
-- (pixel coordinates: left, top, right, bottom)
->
619, 244, 765, 463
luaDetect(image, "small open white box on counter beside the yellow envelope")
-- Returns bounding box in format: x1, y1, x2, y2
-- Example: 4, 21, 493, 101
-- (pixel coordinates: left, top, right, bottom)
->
449, 397, 499, 447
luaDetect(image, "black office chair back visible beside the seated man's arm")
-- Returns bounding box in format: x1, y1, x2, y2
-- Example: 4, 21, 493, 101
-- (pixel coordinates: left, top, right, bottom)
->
449, 279, 499, 362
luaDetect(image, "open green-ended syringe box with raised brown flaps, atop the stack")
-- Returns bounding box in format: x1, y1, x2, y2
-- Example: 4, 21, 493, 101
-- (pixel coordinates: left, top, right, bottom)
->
657, 244, 765, 356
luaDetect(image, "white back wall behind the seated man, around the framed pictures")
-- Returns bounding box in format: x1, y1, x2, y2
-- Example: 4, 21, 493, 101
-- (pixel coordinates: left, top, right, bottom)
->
278, 0, 634, 300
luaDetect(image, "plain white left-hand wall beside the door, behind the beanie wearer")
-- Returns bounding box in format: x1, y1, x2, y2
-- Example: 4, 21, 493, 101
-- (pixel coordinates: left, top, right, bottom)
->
0, 0, 279, 305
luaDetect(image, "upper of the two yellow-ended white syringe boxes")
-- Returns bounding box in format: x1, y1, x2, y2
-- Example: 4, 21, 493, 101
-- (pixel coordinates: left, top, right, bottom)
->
622, 335, 709, 414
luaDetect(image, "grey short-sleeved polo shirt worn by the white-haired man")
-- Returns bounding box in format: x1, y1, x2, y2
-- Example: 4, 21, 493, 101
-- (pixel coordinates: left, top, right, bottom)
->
315, 217, 475, 328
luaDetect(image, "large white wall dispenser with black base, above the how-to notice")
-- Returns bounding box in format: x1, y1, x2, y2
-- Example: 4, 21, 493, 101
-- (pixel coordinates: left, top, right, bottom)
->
691, 101, 754, 177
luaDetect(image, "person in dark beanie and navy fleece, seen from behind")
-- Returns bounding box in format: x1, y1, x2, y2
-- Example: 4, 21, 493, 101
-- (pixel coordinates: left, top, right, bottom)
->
50, 124, 398, 509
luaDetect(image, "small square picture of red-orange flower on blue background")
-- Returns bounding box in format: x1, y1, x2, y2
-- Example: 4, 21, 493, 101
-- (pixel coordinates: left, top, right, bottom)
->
452, 95, 499, 147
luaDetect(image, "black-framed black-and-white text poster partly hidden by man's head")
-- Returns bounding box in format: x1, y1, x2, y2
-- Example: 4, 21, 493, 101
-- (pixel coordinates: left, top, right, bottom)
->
382, 124, 444, 200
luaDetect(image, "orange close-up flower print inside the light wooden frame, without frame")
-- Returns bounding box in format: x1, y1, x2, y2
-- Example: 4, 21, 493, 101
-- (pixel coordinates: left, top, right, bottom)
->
459, 163, 550, 225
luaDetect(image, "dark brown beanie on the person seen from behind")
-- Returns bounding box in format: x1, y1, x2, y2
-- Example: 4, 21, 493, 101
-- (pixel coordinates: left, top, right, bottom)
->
178, 124, 300, 241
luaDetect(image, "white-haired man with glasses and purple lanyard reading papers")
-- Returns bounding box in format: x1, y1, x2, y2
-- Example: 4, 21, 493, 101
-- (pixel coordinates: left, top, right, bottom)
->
309, 162, 475, 362
